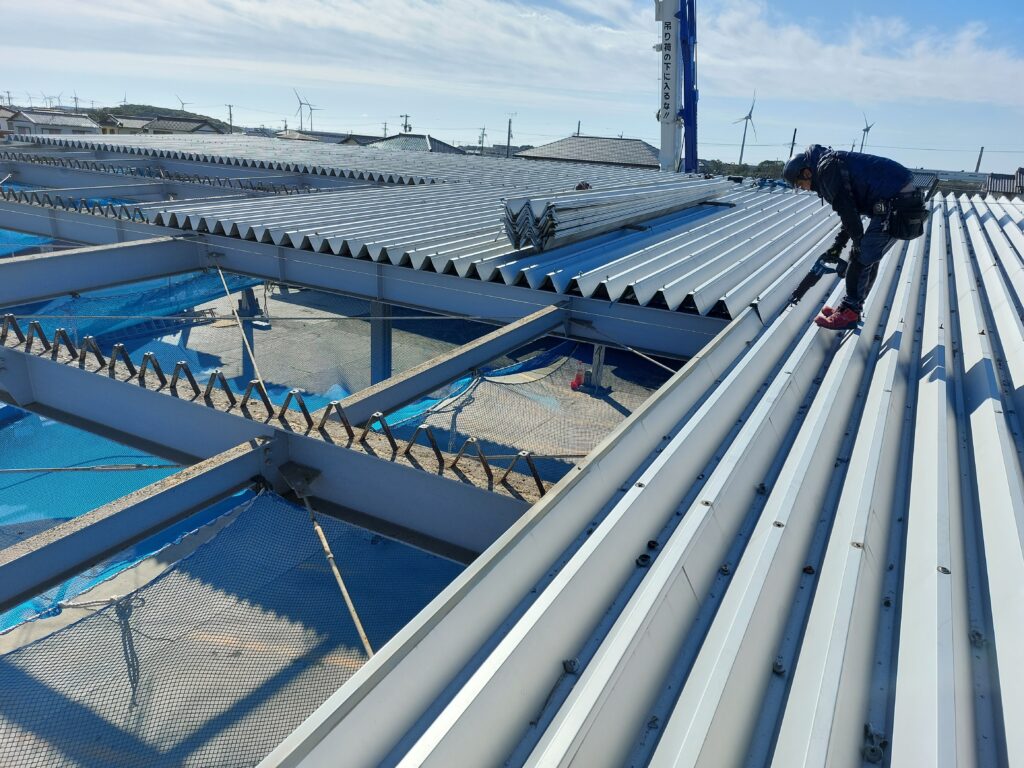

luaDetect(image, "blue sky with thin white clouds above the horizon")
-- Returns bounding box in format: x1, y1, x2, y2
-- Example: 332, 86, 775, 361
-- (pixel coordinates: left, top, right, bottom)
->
6, 0, 1024, 172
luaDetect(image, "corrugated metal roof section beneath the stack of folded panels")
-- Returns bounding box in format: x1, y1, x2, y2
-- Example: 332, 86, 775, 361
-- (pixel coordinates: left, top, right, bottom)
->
105, 181, 838, 317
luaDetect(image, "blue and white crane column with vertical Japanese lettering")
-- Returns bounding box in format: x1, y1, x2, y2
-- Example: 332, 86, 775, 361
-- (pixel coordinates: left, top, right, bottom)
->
654, 0, 697, 173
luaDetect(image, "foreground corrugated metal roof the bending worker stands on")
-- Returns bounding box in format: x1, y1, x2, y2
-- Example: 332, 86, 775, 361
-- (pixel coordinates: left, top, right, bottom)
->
264, 189, 1024, 768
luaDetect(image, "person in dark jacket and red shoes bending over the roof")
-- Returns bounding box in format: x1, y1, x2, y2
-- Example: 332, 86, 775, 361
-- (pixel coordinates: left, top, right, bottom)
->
782, 144, 928, 331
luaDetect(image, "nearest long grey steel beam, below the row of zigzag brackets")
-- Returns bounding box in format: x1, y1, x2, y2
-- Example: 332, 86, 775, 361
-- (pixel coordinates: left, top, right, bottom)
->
0, 346, 527, 552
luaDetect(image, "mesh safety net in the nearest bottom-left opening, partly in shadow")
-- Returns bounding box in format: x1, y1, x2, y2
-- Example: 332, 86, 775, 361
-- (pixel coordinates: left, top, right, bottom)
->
0, 494, 462, 768
